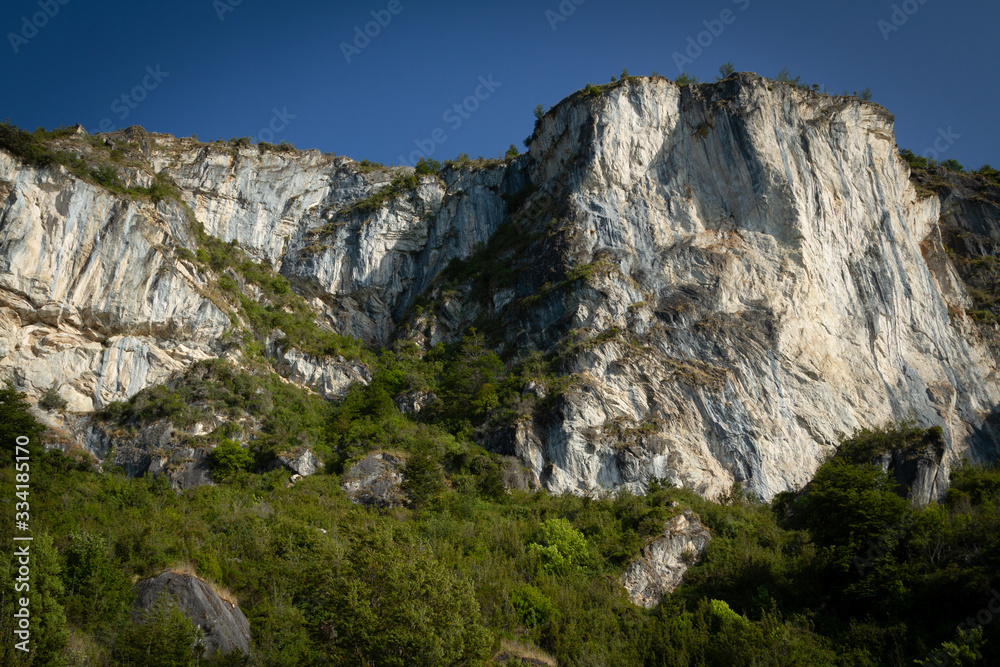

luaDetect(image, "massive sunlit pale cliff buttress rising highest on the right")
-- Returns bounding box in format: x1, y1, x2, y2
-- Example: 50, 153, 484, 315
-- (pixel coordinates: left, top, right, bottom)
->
414, 74, 1000, 498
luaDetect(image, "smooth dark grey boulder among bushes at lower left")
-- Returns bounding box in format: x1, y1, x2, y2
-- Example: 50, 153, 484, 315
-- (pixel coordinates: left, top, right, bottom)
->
134, 572, 251, 656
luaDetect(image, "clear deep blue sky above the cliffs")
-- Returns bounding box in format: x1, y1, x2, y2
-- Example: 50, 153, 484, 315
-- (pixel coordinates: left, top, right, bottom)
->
0, 0, 1000, 167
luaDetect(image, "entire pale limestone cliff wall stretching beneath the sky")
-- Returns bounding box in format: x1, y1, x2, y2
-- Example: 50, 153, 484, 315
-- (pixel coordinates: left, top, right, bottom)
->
0, 74, 1000, 499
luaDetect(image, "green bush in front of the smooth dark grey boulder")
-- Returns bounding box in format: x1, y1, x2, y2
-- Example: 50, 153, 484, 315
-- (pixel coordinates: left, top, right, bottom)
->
115, 593, 201, 667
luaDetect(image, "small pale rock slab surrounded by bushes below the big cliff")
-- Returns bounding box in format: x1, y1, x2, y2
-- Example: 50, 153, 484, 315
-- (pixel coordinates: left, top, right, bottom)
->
620, 510, 712, 609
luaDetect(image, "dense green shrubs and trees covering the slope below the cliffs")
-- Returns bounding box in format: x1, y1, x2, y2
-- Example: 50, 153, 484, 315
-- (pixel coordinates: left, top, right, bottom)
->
0, 374, 1000, 667
